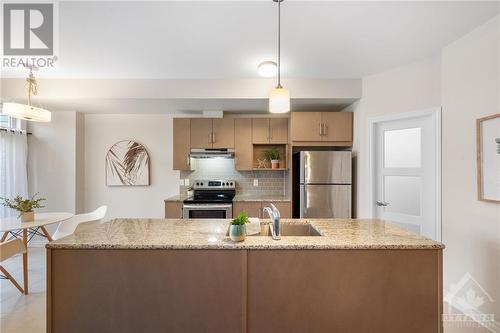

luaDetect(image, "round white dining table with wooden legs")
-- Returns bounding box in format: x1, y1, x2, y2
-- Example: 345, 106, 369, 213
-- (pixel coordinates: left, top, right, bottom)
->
0, 212, 73, 294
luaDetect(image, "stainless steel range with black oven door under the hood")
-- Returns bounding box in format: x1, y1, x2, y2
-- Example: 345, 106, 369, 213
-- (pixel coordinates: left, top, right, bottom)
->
182, 179, 236, 219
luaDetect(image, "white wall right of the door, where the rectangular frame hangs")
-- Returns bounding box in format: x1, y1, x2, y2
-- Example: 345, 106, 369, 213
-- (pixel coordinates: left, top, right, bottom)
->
441, 16, 500, 321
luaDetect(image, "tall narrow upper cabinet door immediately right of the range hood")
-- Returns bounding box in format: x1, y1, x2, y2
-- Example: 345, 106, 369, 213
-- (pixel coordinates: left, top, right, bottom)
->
234, 118, 253, 170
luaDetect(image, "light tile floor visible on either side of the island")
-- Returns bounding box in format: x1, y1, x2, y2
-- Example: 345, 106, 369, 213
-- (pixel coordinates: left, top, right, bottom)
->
0, 247, 489, 333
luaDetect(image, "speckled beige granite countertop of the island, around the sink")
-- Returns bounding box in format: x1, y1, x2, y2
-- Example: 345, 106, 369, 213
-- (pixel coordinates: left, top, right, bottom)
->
46, 219, 444, 250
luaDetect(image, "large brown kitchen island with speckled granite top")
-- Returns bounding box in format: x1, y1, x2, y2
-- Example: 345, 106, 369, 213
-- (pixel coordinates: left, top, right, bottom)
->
47, 219, 444, 332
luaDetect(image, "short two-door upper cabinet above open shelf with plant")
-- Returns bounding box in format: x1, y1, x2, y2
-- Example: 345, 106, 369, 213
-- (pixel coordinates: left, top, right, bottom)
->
252, 118, 288, 144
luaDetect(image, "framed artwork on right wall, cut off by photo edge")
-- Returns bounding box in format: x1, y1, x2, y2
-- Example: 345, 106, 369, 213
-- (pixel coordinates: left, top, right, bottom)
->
476, 113, 500, 203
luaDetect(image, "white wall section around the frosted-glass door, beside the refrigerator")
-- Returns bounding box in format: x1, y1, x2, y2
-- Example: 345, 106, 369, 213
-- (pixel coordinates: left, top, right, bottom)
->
353, 56, 441, 217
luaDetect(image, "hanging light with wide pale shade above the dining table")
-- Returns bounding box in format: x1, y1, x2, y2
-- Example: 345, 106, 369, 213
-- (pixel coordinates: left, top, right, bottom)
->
2, 67, 51, 122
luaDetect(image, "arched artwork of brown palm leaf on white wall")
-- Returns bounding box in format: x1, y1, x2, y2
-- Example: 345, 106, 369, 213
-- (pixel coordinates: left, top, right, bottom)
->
106, 140, 149, 186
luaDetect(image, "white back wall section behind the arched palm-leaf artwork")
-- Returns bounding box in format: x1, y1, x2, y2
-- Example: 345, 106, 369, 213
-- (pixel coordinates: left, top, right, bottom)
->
85, 114, 179, 218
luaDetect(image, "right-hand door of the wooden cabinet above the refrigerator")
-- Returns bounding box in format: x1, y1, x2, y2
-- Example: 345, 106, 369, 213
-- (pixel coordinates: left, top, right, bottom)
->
321, 112, 352, 141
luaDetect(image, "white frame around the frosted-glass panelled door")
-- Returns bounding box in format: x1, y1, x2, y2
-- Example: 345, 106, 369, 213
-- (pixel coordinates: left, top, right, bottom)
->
368, 106, 442, 241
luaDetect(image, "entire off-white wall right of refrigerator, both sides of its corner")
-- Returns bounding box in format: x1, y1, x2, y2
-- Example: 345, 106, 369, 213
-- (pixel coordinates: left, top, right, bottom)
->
353, 17, 500, 321
